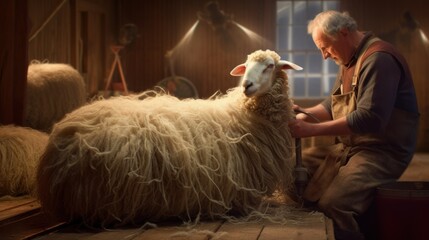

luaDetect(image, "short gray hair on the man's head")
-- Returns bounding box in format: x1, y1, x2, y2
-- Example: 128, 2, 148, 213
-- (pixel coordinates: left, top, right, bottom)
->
307, 10, 357, 39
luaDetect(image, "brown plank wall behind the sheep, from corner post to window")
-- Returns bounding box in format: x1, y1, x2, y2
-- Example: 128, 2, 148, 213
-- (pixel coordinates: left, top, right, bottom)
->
119, 0, 276, 98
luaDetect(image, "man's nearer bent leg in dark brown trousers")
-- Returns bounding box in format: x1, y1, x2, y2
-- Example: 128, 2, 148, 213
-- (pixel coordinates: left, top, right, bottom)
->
318, 150, 406, 233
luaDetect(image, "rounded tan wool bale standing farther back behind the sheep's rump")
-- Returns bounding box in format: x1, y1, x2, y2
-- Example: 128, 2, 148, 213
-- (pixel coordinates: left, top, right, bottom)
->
24, 61, 86, 132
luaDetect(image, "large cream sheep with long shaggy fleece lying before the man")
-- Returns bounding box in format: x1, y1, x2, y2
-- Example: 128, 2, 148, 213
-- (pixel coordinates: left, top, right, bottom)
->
37, 50, 301, 226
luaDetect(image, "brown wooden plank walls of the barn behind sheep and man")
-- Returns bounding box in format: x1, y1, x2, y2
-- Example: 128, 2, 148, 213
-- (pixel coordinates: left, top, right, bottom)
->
0, 0, 429, 151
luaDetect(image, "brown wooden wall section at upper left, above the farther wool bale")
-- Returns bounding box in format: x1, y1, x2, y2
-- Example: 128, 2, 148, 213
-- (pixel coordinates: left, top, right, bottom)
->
28, 0, 117, 96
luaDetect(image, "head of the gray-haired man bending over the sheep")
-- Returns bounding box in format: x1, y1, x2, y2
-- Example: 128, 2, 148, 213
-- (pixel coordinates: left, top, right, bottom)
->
308, 11, 359, 65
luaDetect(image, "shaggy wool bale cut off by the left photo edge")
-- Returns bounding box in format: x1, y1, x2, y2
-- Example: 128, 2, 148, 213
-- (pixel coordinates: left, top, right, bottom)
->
0, 125, 48, 196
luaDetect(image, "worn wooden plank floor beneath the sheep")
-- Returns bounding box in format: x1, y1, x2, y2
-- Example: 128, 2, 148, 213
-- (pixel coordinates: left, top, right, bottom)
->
0, 153, 429, 240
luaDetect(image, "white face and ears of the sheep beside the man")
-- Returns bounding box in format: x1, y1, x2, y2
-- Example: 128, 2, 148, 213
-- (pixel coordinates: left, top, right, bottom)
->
231, 50, 302, 97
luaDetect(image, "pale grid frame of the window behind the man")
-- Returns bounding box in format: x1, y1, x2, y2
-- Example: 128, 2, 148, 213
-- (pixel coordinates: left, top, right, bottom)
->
276, 0, 340, 99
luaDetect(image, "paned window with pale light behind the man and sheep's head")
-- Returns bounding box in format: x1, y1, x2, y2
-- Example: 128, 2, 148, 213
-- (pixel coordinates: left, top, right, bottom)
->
276, 0, 339, 98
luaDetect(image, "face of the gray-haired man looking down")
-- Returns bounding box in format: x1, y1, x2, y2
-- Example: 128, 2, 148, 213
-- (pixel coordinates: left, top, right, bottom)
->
312, 29, 349, 65
